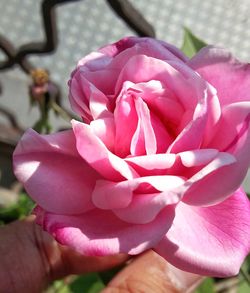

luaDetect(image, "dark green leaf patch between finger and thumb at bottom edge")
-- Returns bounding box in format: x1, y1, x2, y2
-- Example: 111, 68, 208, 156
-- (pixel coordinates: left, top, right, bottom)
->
69, 273, 105, 293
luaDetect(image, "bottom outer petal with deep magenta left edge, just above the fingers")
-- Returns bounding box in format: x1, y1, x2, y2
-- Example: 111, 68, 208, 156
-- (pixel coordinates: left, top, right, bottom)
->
35, 206, 174, 256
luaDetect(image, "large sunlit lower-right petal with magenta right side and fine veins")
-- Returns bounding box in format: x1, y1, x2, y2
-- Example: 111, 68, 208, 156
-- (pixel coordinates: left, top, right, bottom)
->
155, 190, 250, 277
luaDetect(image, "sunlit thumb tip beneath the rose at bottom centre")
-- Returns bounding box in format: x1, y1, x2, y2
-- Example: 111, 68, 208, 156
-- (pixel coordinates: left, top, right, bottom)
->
102, 250, 202, 293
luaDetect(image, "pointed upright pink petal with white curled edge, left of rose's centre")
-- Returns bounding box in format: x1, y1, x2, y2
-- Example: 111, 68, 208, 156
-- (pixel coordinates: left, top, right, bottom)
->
72, 120, 138, 181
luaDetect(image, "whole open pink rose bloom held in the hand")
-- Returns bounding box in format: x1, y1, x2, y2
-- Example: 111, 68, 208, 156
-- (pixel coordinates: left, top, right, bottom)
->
14, 37, 250, 276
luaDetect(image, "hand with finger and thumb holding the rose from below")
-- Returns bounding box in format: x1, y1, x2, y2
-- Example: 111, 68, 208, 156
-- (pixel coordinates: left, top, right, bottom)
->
0, 216, 201, 293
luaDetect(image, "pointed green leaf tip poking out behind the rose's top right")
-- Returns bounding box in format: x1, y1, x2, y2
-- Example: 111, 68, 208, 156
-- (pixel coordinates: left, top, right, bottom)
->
181, 27, 207, 58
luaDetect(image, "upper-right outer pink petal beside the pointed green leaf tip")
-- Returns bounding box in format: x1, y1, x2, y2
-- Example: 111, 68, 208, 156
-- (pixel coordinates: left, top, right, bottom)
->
187, 46, 250, 106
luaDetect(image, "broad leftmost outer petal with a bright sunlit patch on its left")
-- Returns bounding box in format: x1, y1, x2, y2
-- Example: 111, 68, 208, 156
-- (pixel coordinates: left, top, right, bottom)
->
13, 129, 99, 214
